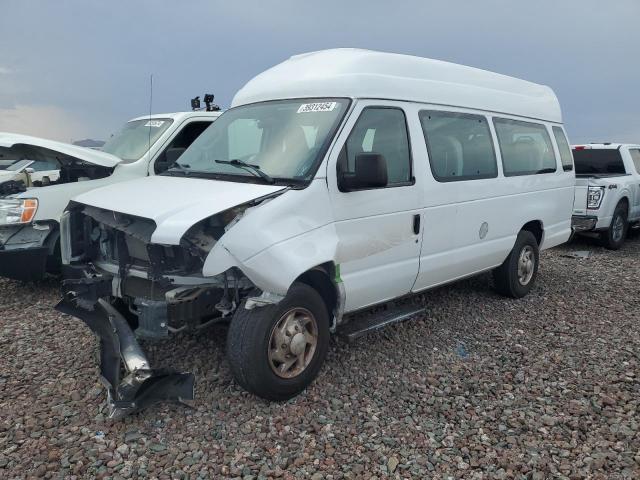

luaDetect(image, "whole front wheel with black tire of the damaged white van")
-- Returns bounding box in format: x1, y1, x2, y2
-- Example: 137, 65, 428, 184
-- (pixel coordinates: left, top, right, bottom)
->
227, 283, 329, 400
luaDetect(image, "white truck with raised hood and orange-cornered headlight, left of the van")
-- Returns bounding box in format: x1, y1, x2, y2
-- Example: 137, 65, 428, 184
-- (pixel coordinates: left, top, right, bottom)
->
0, 111, 221, 280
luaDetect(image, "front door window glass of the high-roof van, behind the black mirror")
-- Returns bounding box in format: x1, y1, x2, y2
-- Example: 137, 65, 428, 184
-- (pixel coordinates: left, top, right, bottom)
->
337, 107, 411, 186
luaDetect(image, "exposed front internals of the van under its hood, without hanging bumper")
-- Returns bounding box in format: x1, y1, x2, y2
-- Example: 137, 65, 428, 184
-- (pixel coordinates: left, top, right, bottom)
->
61, 201, 255, 338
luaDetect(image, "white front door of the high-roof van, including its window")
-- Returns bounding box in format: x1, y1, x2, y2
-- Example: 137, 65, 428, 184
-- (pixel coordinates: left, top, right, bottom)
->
327, 101, 422, 311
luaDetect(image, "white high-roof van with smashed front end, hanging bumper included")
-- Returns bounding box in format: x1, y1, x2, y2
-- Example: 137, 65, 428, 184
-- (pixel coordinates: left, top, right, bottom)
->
58, 49, 575, 417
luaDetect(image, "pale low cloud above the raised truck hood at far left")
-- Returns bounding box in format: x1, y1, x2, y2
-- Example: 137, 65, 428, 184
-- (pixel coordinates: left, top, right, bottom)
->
0, 105, 96, 142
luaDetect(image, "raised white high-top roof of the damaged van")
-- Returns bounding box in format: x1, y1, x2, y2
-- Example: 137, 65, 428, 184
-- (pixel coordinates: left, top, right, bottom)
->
232, 48, 562, 123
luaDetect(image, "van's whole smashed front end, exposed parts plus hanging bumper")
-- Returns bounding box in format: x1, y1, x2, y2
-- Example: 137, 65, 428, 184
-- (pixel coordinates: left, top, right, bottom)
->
57, 202, 255, 418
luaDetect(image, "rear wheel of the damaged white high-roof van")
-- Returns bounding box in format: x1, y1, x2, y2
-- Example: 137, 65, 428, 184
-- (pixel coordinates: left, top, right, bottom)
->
493, 230, 540, 298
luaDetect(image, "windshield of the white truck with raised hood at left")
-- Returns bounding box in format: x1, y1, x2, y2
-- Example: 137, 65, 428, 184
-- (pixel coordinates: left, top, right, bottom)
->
101, 118, 173, 163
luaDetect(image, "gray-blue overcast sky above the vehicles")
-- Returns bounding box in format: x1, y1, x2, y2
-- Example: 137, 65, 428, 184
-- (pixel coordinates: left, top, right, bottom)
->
0, 0, 640, 143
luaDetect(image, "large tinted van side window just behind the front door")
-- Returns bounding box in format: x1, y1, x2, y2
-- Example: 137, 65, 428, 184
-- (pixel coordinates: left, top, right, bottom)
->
419, 111, 498, 182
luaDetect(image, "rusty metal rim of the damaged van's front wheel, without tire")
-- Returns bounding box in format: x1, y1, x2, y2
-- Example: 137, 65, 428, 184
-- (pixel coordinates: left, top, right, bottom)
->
269, 308, 318, 378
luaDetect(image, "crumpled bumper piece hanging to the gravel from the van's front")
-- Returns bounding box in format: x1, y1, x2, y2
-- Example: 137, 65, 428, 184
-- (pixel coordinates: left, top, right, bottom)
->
56, 296, 195, 419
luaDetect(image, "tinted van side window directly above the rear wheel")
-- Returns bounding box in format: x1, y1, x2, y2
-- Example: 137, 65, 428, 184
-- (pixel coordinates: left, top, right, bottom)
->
493, 118, 557, 177
